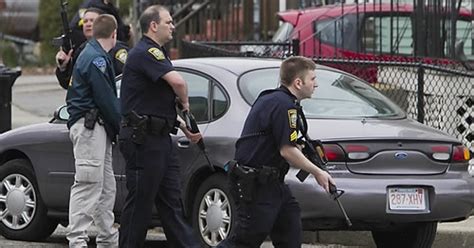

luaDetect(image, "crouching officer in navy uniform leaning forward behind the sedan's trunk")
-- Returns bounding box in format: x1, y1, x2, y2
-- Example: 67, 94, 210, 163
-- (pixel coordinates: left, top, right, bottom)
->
218, 57, 334, 248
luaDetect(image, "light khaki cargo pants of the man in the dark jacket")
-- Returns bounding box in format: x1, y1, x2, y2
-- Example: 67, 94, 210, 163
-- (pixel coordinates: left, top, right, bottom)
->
66, 118, 118, 247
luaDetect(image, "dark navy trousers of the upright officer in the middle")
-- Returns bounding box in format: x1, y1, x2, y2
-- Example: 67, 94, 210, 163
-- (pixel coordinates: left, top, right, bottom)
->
120, 130, 199, 248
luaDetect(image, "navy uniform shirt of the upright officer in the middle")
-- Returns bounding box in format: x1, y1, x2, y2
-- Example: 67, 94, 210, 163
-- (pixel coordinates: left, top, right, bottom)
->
120, 36, 176, 123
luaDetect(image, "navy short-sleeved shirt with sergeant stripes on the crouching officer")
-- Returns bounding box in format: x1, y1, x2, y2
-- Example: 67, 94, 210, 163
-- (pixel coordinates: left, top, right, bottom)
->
235, 86, 298, 167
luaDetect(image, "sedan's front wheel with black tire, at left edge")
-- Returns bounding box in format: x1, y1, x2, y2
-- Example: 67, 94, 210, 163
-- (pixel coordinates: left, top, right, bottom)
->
0, 159, 58, 241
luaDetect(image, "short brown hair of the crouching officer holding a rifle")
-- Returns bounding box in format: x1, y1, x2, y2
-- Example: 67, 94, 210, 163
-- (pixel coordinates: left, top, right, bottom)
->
280, 56, 316, 86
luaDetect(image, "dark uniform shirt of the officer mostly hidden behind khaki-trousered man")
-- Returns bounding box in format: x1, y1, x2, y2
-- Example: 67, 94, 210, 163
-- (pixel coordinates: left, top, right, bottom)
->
56, 41, 128, 90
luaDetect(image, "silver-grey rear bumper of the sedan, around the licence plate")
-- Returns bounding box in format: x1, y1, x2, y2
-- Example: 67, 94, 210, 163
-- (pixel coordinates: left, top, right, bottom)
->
285, 169, 474, 229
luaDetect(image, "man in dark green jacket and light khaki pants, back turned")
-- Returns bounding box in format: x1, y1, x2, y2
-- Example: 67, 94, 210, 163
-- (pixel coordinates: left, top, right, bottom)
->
66, 14, 120, 248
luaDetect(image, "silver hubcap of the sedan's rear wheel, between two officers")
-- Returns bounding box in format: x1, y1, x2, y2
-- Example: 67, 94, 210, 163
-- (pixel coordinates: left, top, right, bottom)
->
198, 189, 231, 246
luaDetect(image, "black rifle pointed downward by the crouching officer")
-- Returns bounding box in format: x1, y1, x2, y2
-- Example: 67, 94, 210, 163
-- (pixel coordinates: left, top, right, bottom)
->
296, 108, 352, 227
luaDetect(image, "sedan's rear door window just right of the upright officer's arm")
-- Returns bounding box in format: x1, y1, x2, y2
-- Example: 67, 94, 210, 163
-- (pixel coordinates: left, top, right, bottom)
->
179, 71, 211, 122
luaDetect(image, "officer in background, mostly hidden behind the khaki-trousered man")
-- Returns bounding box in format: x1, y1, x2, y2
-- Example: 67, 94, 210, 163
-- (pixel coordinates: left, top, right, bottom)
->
56, 8, 128, 89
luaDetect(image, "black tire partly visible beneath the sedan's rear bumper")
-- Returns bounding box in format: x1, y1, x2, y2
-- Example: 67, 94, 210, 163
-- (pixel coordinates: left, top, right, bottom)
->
372, 222, 438, 248
